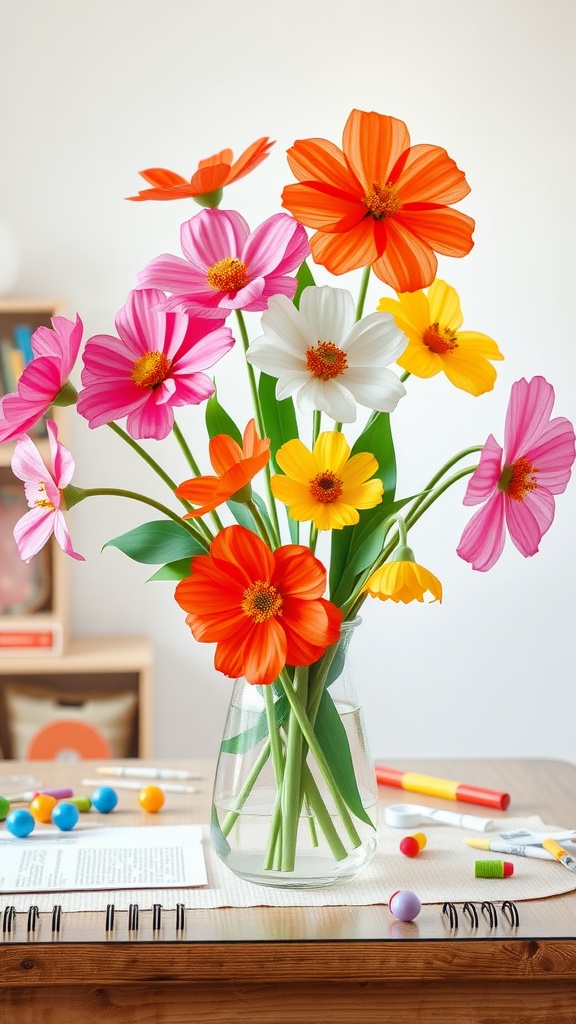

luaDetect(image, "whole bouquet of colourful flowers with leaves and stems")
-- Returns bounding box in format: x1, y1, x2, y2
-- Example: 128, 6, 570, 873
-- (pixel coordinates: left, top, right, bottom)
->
0, 110, 575, 877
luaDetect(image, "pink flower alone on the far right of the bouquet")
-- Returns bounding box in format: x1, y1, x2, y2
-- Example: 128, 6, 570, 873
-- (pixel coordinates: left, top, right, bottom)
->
457, 377, 575, 572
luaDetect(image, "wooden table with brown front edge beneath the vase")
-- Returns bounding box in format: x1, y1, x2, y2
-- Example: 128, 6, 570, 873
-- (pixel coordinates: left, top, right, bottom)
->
0, 760, 576, 1024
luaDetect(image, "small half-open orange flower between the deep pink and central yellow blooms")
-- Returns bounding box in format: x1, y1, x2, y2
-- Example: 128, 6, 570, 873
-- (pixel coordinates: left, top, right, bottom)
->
176, 420, 270, 519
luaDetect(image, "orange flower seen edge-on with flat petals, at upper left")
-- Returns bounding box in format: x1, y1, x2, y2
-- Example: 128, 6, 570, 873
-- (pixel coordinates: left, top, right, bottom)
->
128, 137, 274, 206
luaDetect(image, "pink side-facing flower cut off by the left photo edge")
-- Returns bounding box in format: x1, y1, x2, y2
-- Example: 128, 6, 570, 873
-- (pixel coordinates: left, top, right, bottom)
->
0, 316, 83, 441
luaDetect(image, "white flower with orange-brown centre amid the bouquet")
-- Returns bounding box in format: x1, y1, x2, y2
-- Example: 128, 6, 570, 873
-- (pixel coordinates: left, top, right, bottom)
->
246, 286, 408, 423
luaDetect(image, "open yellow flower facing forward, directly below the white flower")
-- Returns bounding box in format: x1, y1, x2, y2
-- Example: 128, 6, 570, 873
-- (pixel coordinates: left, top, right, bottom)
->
271, 430, 383, 529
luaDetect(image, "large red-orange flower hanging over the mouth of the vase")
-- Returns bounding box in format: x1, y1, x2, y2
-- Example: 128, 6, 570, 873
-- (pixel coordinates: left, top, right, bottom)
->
175, 526, 342, 685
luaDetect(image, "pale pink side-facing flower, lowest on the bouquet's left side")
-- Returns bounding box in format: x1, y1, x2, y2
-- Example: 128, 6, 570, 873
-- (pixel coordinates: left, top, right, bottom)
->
11, 420, 84, 562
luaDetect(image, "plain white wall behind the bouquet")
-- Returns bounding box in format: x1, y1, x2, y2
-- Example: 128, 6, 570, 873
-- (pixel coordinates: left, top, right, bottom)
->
0, 0, 576, 760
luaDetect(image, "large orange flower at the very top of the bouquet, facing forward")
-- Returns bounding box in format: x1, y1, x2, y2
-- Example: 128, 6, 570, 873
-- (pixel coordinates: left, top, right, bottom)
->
282, 110, 474, 292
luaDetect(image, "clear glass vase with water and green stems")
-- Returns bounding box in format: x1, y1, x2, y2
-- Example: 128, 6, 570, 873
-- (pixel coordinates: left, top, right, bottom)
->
211, 618, 378, 888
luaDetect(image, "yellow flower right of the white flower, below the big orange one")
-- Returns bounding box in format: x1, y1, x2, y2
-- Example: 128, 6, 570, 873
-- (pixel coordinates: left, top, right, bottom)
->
378, 281, 504, 395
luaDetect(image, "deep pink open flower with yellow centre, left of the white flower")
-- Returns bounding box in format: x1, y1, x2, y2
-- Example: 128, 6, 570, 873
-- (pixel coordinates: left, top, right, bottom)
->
78, 288, 234, 440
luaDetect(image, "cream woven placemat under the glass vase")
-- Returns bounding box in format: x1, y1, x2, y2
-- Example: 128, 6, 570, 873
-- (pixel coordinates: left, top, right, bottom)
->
3, 816, 576, 913
